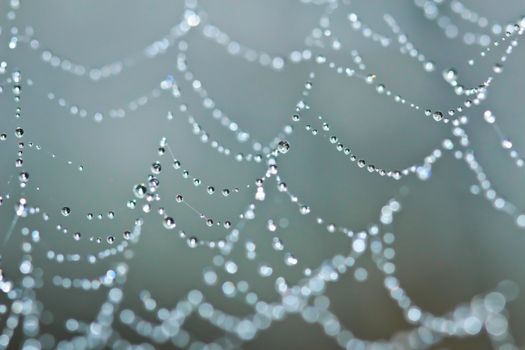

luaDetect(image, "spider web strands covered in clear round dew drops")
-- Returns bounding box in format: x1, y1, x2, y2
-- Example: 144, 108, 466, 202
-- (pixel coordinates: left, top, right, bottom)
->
0, 0, 525, 349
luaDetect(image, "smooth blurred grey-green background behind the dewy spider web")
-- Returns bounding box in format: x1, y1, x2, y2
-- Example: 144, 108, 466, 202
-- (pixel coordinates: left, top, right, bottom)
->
0, 0, 525, 349
